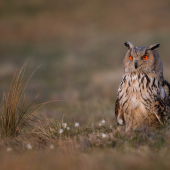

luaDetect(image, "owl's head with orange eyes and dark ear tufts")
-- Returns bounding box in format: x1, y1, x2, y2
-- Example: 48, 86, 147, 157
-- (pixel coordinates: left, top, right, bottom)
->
123, 41, 163, 78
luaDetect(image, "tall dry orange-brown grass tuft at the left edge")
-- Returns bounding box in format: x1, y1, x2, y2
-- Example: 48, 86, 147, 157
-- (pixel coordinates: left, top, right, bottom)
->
0, 62, 41, 138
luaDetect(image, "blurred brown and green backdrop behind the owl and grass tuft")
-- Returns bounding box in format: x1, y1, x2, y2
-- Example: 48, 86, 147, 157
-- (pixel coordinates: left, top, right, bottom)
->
0, 0, 170, 123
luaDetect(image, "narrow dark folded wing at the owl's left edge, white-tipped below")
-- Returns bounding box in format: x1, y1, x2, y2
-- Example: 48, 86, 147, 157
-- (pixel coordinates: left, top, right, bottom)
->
115, 98, 124, 125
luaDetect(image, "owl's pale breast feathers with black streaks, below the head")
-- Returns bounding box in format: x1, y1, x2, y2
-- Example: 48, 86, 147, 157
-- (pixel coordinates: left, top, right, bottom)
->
118, 74, 163, 113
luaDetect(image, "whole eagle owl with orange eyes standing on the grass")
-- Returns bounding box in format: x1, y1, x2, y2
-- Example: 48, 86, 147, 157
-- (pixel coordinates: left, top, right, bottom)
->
115, 41, 170, 131
